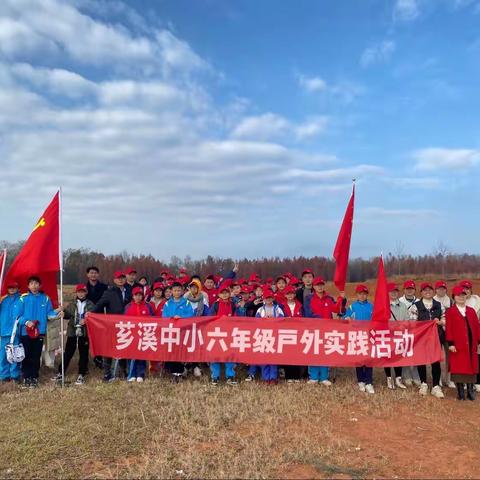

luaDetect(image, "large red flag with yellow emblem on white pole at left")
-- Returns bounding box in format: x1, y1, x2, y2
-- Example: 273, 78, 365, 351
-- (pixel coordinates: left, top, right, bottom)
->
1, 192, 61, 305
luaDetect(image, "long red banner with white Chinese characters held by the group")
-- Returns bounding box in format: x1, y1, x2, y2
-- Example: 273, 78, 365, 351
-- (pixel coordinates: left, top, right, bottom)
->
87, 313, 442, 367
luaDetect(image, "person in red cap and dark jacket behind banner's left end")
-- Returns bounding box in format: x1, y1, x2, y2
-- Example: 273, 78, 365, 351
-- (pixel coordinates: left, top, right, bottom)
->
93, 271, 132, 382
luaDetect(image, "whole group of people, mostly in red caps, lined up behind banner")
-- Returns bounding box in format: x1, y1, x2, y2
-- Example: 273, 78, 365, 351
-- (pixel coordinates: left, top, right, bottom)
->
0, 266, 480, 400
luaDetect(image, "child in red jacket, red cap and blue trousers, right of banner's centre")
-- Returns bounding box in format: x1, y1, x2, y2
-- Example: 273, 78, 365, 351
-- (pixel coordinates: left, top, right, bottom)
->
304, 278, 345, 387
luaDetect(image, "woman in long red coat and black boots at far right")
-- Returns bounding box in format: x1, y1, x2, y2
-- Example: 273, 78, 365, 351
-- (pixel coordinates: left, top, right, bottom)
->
446, 285, 480, 401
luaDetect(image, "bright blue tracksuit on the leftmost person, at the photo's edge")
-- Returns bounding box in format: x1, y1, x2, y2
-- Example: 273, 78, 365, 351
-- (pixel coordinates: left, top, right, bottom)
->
0, 293, 20, 380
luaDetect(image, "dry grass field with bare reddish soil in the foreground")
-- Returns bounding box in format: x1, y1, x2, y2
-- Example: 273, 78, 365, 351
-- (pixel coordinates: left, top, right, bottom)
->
0, 280, 480, 479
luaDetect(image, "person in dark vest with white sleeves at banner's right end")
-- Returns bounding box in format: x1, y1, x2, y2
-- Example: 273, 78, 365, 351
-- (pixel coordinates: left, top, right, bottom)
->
409, 282, 445, 398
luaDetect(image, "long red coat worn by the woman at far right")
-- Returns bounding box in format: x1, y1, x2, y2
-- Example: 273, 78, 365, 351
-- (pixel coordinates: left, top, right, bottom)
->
445, 305, 480, 375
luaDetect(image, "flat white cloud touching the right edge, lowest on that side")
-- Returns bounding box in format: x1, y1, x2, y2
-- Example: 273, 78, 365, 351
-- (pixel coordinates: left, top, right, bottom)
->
411, 148, 480, 174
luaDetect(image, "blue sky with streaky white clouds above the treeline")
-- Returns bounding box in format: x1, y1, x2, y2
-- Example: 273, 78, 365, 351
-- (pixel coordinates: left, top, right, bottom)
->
0, 0, 480, 259
